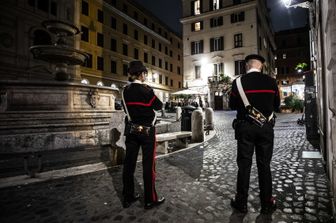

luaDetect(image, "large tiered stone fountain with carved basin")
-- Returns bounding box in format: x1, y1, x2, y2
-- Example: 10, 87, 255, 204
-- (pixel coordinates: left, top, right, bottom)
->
0, 20, 124, 176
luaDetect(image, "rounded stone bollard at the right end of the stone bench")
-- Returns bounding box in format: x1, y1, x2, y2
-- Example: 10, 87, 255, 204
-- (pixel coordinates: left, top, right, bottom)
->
191, 110, 204, 142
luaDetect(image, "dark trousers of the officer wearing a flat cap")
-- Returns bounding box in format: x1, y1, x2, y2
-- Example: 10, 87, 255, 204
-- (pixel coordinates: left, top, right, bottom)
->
236, 121, 274, 205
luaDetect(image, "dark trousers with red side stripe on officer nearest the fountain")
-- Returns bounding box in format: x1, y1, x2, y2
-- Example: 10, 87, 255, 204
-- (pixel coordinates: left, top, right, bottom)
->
123, 127, 157, 203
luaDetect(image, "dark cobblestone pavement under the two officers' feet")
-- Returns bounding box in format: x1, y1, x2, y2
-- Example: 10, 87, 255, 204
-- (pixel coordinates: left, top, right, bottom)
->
0, 112, 332, 223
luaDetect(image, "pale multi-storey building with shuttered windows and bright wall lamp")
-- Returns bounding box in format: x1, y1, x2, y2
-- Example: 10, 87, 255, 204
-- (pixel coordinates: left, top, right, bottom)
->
181, 0, 275, 109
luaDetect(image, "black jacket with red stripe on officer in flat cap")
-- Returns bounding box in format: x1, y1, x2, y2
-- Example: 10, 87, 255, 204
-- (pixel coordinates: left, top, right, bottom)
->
229, 72, 280, 119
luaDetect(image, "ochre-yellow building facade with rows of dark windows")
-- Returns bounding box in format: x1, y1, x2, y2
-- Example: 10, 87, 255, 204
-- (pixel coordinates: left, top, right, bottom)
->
76, 0, 183, 101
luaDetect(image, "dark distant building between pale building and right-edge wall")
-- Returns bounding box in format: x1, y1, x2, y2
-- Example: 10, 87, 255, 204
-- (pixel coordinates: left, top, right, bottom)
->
275, 26, 310, 101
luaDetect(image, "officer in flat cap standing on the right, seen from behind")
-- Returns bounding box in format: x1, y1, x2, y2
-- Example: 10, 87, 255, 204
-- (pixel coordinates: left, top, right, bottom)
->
229, 54, 280, 214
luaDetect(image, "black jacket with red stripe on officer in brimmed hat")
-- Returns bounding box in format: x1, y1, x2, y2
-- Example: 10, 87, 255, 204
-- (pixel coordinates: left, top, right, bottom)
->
124, 83, 162, 126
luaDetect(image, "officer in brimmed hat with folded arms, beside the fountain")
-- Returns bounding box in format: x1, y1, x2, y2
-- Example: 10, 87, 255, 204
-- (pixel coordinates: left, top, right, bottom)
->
123, 61, 165, 209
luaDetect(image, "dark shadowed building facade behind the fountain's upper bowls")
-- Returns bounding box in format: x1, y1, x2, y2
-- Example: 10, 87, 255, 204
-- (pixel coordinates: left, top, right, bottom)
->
0, 0, 75, 80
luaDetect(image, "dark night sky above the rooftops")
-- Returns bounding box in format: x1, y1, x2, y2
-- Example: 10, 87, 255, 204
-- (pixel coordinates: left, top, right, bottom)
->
133, 0, 308, 34
